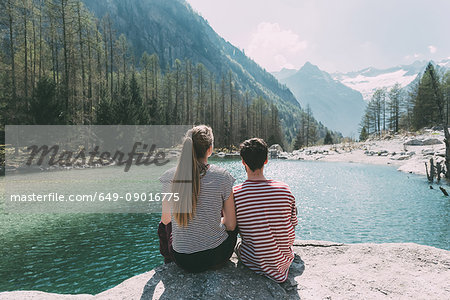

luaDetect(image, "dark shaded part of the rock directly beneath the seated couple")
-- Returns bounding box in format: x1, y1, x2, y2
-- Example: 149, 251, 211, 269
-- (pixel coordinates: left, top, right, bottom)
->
141, 257, 304, 300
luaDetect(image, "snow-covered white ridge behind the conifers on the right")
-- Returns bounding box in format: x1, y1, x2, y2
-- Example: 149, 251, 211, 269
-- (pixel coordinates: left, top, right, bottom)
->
332, 59, 450, 101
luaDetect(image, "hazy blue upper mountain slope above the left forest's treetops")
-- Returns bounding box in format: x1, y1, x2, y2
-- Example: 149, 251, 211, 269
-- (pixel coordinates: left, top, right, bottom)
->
84, 0, 312, 141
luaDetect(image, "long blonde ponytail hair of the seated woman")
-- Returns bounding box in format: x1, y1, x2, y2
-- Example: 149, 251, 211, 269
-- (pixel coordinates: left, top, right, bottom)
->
172, 125, 214, 227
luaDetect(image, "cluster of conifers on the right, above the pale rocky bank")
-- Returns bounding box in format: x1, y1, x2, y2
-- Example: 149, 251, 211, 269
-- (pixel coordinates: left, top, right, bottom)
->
360, 63, 450, 140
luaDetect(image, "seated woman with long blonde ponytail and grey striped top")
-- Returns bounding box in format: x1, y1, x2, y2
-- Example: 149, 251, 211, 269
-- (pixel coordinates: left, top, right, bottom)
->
158, 125, 237, 272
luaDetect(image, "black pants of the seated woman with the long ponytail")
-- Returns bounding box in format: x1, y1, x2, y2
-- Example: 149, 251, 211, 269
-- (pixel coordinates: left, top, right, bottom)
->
158, 222, 238, 273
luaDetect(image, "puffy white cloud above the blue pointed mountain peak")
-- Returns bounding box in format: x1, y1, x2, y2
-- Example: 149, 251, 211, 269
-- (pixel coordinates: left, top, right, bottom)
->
247, 22, 308, 71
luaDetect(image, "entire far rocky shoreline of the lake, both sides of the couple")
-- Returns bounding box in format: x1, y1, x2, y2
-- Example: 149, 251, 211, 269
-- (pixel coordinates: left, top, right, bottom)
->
4, 129, 445, 175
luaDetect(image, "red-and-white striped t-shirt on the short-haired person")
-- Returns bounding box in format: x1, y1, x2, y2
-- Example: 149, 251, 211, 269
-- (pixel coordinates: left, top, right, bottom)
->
233, 180, 297, 282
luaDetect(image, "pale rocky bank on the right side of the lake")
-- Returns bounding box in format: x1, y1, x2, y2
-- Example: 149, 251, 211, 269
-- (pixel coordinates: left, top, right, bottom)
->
281, 130, 445, 175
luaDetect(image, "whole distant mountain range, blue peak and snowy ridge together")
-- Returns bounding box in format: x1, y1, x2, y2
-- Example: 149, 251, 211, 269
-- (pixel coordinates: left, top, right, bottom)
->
272, 58, 450, 136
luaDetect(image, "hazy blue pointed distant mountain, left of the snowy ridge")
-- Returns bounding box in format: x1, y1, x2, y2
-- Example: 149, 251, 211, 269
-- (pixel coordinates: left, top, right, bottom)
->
273, 62, 366, 136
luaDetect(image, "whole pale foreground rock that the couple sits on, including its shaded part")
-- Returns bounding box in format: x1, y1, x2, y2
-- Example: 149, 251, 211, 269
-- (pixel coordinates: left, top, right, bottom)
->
0, 240, 450, 300
